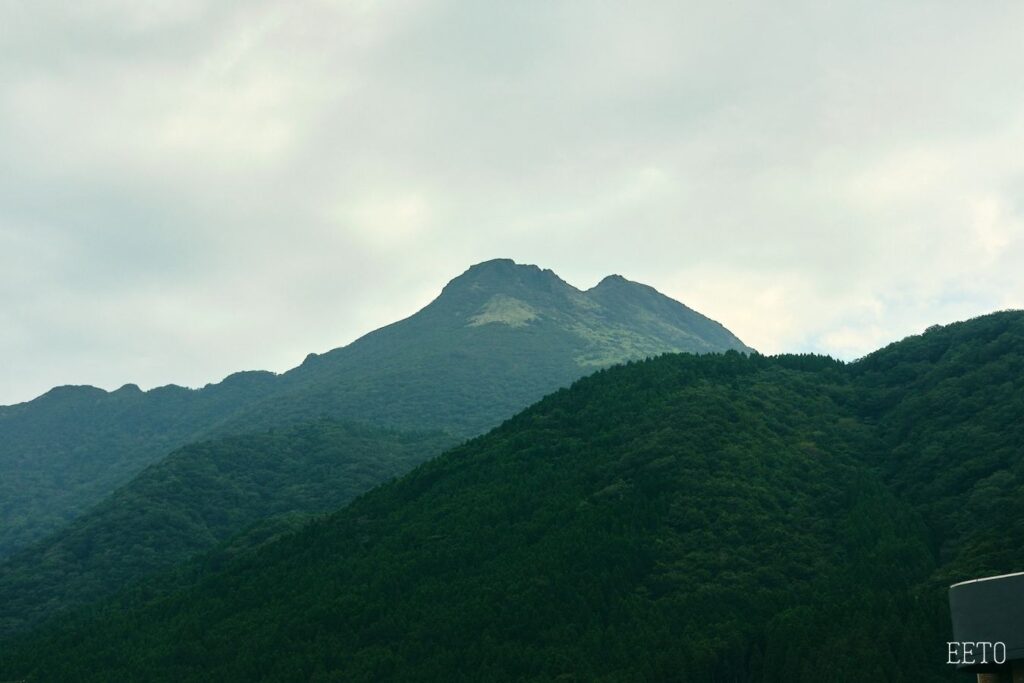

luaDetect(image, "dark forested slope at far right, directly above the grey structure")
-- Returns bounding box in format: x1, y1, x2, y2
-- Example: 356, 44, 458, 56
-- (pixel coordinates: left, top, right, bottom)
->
849, 311, 1024, 588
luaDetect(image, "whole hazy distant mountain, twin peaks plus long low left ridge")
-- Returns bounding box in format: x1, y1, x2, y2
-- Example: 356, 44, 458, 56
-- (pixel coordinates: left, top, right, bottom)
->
0, 260, 748, 558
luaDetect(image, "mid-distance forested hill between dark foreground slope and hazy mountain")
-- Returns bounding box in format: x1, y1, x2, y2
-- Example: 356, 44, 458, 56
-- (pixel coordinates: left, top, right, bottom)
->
0, 422, 453, 634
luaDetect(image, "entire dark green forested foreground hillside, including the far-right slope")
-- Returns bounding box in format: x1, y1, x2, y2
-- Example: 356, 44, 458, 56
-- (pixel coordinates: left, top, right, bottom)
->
0, 312, 1024, 681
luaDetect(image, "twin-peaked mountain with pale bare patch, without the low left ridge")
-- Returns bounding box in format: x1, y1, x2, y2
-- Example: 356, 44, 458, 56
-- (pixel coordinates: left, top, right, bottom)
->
230, 259, 751, 435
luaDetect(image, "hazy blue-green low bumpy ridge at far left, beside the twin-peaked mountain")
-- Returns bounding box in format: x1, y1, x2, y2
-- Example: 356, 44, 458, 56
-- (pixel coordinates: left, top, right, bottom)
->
0, 373, 272, 559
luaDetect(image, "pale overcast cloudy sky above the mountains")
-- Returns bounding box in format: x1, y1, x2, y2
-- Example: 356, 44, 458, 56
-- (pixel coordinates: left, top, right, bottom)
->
0, 0, 1024, 403
